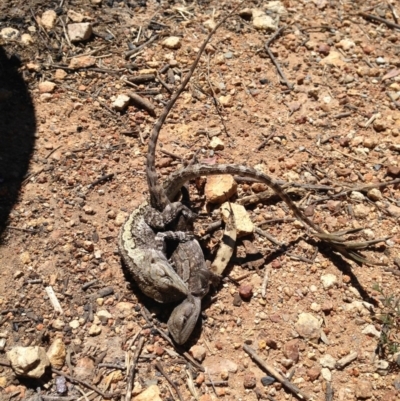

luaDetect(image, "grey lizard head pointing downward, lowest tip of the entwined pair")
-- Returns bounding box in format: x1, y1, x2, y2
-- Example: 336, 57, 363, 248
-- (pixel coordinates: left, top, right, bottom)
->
168, 294, 201, 345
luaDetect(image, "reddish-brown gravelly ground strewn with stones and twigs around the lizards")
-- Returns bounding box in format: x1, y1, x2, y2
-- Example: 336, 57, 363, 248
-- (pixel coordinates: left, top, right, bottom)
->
0, 0, 400, 401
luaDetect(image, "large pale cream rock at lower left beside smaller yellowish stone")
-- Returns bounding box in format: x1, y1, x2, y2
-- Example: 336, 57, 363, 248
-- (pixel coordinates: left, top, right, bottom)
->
7, 346, 50, 379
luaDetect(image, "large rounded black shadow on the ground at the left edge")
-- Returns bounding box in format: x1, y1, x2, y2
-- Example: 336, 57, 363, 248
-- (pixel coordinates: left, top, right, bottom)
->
0, 46, 36, 236
